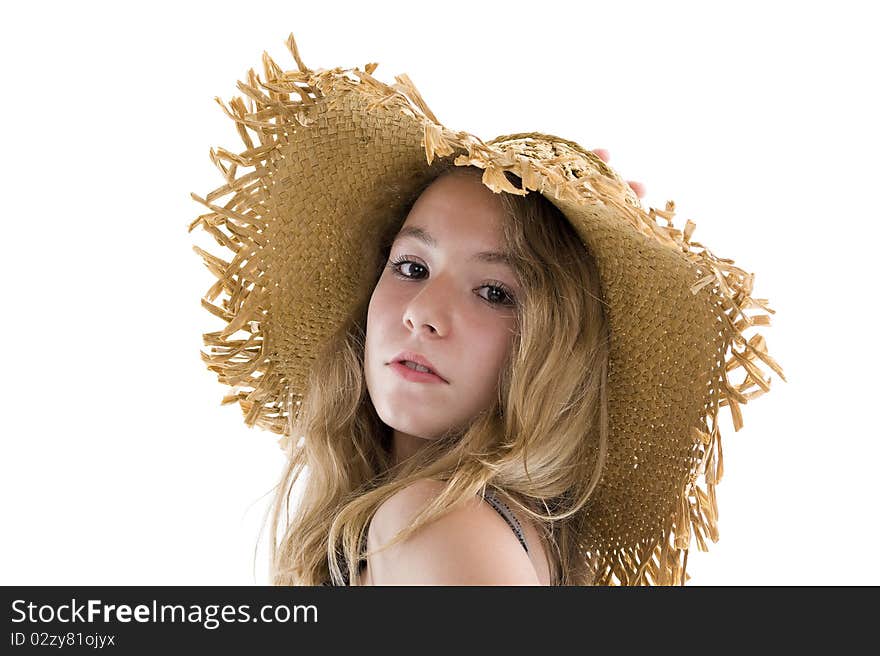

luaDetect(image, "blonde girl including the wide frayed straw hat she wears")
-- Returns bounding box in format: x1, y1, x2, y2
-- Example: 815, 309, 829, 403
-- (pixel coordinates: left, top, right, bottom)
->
190, 35, 782, 585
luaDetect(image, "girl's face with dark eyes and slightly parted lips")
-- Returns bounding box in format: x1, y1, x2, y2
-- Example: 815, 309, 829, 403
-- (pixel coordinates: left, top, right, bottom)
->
364, 170, 520, 440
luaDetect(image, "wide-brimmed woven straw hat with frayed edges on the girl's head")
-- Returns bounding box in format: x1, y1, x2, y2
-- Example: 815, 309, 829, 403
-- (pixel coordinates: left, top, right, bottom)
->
189, 35, 785, 585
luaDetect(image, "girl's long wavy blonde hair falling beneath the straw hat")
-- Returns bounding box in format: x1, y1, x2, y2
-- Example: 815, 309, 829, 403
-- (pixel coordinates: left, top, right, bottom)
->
269, 163, 609, 585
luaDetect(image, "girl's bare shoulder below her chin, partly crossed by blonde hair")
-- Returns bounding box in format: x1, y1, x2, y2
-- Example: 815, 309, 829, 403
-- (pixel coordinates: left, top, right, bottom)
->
368, 479, 538, 585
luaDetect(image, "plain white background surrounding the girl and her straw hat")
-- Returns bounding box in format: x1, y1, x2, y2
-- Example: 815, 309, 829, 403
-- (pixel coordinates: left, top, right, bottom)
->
0, 0, 880, 585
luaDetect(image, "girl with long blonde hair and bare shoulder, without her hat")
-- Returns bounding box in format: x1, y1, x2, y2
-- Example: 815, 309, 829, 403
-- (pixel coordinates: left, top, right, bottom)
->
274, 163, 607, 585
